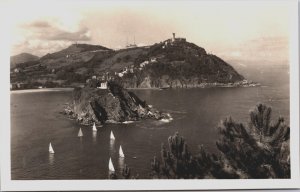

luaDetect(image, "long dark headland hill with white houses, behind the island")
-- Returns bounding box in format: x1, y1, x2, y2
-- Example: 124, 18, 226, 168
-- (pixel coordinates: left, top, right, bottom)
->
11, 38, 251, 88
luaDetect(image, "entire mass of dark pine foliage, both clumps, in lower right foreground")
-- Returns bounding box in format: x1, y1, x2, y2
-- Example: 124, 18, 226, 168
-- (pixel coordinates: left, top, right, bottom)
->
151, 104, 290, 179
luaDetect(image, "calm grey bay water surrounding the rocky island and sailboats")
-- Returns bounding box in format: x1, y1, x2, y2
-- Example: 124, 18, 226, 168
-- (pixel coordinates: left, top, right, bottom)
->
11, 65, 289, 179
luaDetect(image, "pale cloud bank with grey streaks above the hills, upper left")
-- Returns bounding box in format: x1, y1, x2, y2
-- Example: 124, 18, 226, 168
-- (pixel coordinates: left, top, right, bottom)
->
11, 20, 91, 56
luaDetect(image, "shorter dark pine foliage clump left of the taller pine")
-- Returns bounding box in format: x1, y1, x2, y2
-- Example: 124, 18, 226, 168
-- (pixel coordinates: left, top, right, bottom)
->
151, 133, 238, 179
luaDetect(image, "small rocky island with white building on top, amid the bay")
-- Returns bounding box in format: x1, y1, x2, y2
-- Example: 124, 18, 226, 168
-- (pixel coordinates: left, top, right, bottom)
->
63, 81, 170, 125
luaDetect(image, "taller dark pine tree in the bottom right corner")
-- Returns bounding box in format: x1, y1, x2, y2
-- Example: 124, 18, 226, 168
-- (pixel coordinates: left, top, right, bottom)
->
217, 104, 290, 178
